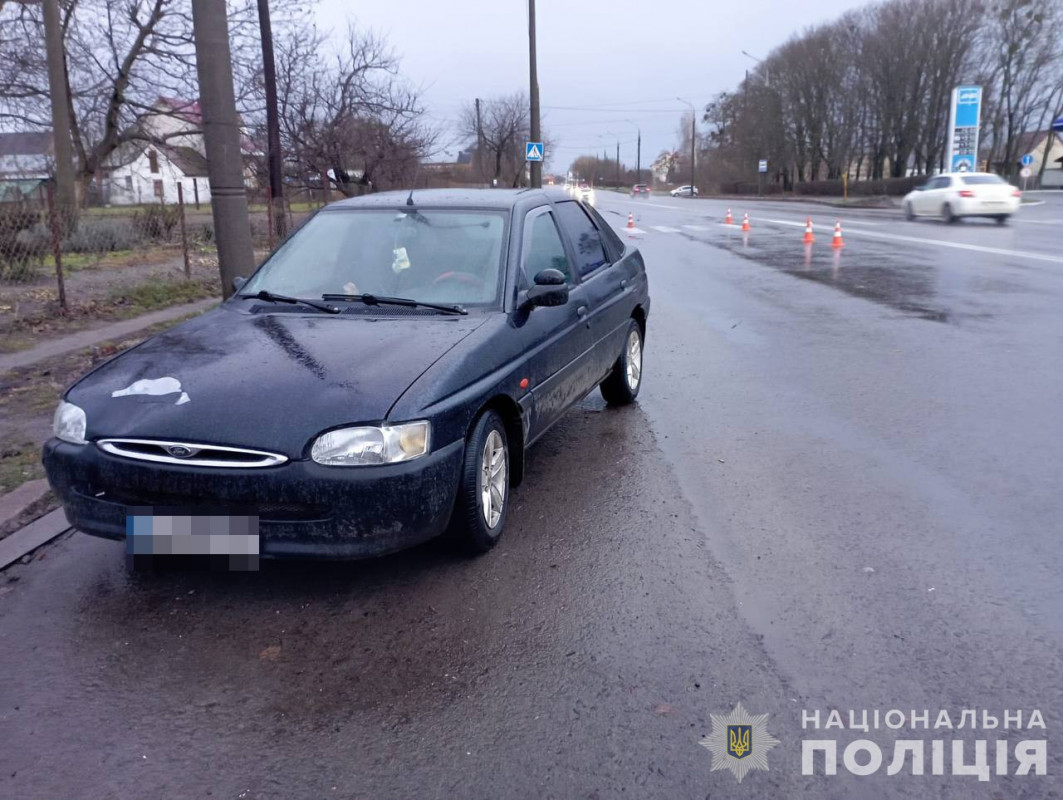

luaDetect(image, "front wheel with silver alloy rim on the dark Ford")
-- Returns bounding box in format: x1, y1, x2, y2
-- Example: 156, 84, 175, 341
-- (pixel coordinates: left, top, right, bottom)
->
449, 410, 509, 556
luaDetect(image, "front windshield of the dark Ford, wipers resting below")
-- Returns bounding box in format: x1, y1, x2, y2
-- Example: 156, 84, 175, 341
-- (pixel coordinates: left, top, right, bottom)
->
241, 207, 505, 305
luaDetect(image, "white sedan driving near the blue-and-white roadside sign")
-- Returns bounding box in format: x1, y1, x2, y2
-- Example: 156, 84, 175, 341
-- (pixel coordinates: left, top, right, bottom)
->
904, 172, 1023, 224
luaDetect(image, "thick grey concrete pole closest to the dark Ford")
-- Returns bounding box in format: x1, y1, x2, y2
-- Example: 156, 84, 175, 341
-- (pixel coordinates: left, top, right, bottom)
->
191, 0, 255, 297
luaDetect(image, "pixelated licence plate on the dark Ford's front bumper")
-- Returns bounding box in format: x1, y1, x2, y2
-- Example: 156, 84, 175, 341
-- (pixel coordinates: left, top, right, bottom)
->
125, 508, 258, 571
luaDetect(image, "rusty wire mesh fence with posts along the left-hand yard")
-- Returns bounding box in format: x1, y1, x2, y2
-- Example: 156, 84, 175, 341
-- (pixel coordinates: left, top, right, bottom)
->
0, 188, 311, 310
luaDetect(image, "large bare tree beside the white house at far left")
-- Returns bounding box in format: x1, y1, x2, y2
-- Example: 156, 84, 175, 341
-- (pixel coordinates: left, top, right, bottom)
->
0, 0, 308, 195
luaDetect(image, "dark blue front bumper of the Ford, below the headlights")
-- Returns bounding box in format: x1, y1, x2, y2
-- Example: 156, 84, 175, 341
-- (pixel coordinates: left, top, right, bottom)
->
44, 439, 465, 558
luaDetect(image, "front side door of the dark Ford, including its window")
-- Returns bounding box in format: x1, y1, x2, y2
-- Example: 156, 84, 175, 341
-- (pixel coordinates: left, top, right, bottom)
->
513, 201, 593, 441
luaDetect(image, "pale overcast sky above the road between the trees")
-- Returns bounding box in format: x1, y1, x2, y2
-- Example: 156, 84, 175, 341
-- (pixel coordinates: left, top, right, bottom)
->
318, 0, 865, 173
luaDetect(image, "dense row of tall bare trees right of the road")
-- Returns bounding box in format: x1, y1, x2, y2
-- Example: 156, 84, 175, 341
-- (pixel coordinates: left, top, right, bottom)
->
697, 0, 1063, 189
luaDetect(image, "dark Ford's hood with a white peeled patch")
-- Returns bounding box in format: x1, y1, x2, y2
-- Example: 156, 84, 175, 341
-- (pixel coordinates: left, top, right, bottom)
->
67, 306, 486, 458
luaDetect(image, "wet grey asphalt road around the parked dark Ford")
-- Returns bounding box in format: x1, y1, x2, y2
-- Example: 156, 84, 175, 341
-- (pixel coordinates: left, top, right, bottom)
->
0, 192, 1063, 799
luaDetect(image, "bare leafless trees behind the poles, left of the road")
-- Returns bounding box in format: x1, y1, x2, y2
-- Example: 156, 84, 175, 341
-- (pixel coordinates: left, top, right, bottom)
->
0, 0, 437, 197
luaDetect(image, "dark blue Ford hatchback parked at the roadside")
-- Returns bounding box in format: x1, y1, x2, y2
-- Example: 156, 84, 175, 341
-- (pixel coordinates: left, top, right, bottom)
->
44, 190, 649, 558
